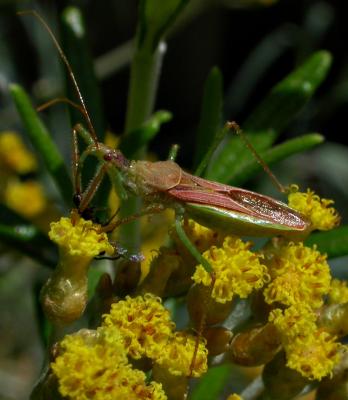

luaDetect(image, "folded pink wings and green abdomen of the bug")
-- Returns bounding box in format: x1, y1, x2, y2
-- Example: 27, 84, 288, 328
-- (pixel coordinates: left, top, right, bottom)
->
168, 173, 309, 238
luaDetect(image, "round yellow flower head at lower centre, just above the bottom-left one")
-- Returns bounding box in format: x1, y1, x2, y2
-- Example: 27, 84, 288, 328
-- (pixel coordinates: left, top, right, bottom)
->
103, 293, 175, 359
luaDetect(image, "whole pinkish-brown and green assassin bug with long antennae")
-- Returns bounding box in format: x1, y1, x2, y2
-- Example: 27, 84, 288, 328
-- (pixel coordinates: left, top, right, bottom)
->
20, 11, 311, 269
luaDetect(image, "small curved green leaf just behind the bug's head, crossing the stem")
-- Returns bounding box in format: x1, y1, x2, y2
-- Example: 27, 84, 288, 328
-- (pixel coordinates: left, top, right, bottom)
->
119, 111, 172, 158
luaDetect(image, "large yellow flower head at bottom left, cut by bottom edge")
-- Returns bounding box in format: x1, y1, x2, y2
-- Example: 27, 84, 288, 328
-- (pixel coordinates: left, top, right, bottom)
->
51, 329, 167, 400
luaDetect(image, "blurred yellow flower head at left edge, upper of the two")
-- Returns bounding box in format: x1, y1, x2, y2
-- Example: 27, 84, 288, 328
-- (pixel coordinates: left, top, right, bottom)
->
0, 131, 37, 174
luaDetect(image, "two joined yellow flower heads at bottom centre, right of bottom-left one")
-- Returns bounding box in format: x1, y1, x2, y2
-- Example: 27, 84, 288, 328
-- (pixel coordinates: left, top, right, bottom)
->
103, 293, 208, 376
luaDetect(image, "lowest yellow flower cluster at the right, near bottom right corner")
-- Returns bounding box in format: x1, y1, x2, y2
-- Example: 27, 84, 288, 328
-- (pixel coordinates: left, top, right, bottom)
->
269, 305, 340, 380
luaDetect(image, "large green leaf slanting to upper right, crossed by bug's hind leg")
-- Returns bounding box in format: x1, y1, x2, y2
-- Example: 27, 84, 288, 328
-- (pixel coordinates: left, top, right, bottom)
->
207, 51, 331, 182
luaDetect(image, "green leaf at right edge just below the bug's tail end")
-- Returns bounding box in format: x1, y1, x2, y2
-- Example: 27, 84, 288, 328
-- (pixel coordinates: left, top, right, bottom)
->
305, 225, 348, 258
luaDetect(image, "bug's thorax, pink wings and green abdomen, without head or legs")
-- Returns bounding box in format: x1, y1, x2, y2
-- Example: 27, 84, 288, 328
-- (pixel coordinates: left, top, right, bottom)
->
119, 161, 310, 239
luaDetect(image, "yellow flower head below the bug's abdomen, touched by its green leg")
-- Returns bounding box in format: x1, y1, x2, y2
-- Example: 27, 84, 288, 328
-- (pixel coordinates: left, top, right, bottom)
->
192, 236, 269, 303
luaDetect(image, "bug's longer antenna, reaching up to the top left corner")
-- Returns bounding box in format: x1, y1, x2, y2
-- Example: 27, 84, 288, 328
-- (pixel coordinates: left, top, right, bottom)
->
17, 10, 98, 147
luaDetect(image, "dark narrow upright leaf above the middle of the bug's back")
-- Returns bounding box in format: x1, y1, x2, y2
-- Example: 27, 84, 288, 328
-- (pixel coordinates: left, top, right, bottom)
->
193, 67, 223, 168
